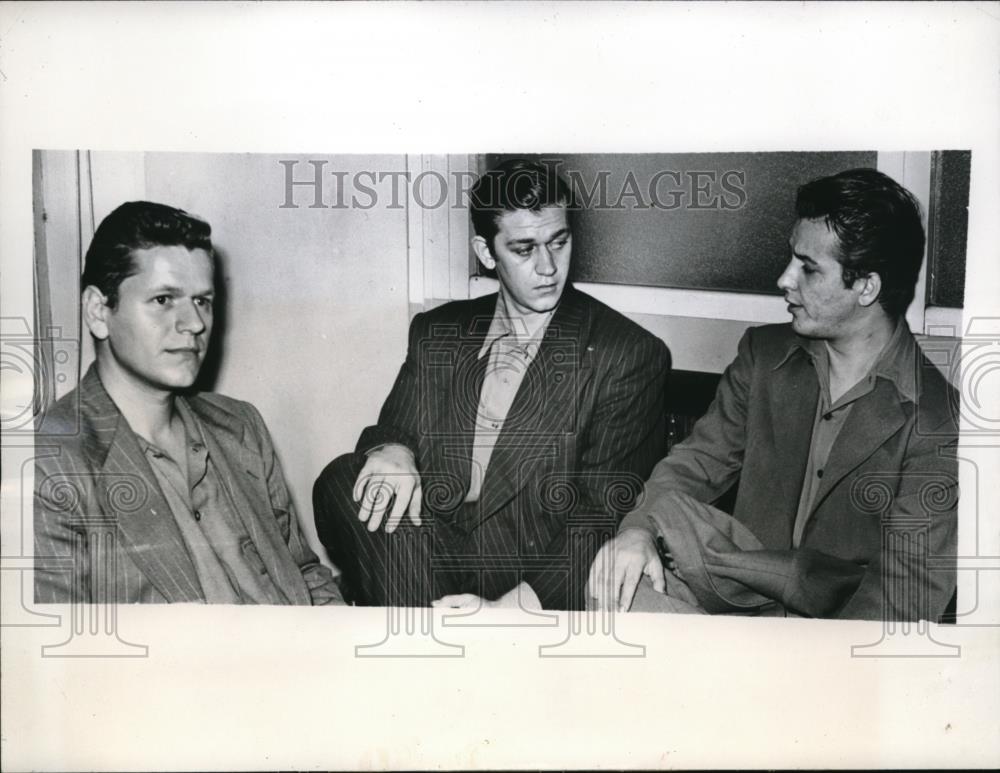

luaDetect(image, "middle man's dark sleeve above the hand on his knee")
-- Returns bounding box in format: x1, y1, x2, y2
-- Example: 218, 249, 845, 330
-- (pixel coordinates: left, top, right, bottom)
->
355, 313, 427, 455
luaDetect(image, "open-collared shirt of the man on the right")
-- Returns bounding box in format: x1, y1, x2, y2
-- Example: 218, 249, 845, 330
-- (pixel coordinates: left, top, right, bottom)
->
792, 320, 916, 548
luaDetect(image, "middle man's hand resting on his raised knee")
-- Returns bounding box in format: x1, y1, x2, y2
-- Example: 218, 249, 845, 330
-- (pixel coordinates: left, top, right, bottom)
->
354, 443, 422, 534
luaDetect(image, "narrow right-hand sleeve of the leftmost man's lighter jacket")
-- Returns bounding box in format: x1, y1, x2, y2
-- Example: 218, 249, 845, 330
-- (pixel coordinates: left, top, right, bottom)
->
245, 403, 344, 606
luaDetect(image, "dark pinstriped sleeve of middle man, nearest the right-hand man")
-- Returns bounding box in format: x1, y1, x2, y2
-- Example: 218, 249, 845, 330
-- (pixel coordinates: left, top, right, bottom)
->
524, 328, 670, 609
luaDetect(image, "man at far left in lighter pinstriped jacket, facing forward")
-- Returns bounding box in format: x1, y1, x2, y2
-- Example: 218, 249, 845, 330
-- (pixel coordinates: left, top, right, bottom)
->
34, 201, 342, 604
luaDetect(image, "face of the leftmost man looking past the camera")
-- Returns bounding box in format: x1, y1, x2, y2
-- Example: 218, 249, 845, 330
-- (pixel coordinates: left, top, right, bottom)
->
92, 246, 214, 392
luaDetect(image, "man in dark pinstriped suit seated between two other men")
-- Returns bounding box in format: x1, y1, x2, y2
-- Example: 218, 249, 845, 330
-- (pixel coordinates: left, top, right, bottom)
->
313, 160, 669, 609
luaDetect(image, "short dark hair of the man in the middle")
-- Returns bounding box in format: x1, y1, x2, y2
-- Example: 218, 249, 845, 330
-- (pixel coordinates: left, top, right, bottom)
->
469, 158, 574, 248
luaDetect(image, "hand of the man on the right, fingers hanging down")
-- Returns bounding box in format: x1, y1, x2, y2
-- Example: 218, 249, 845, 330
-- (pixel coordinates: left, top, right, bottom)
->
587, 529, 666, 612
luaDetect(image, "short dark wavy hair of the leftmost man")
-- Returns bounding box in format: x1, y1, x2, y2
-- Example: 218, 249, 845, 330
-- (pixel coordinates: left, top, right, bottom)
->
80, 201, 213, 308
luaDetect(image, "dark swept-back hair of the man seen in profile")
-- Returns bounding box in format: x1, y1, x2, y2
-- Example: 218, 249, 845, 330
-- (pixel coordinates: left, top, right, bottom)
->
795, 169, 924, 319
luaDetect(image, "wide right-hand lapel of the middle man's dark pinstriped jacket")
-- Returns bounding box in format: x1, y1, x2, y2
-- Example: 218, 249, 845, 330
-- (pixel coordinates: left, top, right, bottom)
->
480, 287, 590, 518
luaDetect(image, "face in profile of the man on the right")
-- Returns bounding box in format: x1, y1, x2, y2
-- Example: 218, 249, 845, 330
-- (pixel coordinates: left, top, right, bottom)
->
778, 220, 864, 340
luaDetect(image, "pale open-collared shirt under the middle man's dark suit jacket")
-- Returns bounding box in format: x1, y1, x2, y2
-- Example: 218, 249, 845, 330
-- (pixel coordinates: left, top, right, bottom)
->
465, 293, 554, 502
